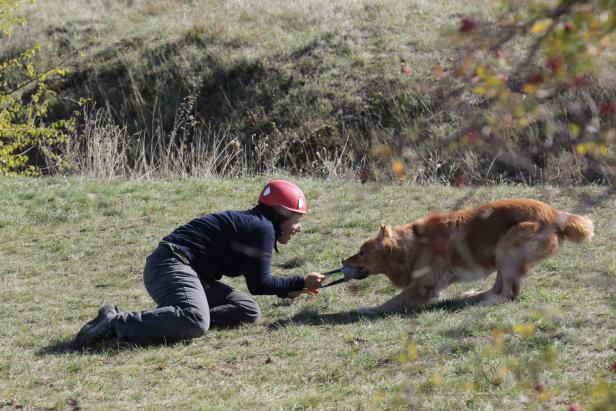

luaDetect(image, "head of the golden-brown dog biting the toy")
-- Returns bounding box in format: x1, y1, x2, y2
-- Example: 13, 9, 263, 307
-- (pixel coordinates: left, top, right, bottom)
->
342, 224, 394, 280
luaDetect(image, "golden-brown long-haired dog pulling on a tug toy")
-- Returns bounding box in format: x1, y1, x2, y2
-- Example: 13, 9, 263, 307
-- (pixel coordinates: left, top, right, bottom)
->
342, 198, 594, 315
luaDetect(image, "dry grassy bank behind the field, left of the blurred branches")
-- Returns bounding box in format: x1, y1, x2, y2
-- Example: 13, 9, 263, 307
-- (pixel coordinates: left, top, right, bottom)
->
0, 0, 616, 185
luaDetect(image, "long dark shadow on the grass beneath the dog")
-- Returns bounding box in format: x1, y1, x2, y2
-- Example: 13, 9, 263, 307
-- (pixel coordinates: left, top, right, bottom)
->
267, 297, 477, 329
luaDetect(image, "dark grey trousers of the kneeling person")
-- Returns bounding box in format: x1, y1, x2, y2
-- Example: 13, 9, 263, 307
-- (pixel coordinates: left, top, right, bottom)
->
115, 244, 261, 343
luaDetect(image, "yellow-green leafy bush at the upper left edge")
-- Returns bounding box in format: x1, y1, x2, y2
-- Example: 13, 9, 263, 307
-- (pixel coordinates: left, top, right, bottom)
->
0, 0, 75, 175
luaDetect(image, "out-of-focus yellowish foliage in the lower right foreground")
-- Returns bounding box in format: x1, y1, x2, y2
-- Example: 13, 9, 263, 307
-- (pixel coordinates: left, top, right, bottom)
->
380, 310, 616, 411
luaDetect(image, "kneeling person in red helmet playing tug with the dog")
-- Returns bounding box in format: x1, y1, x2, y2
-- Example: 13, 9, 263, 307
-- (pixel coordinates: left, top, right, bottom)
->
74, 180, 323, 347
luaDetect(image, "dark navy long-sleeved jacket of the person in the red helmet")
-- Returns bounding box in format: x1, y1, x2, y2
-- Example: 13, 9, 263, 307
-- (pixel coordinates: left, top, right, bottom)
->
163, 206, 304, 296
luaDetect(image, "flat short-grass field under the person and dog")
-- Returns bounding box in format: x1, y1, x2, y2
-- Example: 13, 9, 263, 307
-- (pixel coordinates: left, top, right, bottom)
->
0, 178, 616, 410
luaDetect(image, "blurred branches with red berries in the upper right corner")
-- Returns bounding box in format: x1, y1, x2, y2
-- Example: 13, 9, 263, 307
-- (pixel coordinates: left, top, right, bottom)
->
391, 0, 616, 185
